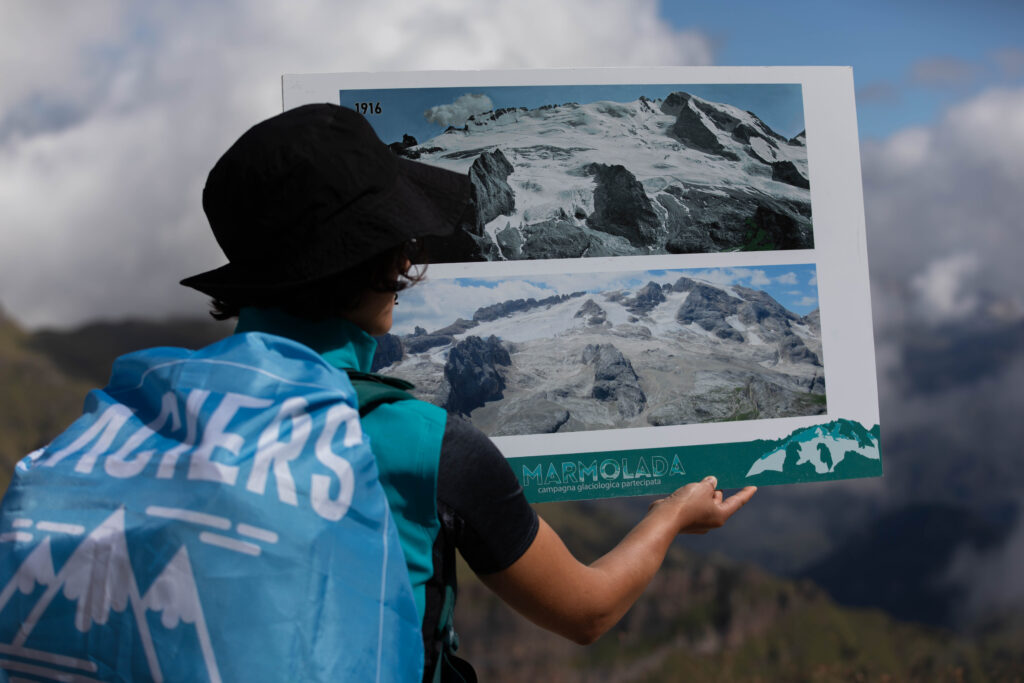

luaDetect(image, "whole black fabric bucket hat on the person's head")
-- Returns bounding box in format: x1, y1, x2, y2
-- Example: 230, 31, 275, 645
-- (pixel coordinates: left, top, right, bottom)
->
181, 104, 470, 300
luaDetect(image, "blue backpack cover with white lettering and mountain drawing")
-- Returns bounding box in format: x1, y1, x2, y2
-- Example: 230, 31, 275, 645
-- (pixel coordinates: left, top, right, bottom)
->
0, 333, 423, 681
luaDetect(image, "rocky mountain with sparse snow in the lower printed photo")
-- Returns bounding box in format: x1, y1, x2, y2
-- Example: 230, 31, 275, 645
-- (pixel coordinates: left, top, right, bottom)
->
376, 278, 825, 435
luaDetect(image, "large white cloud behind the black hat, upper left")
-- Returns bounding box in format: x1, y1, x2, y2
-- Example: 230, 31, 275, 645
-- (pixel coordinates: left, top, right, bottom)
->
0, 0, 711, 326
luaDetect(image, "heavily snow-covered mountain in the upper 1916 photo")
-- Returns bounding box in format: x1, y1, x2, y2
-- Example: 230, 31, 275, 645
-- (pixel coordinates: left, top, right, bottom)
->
392, 92, 814, 262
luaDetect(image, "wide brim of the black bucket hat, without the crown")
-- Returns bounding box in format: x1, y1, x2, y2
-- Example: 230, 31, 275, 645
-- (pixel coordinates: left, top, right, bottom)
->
181, 158, 470, 300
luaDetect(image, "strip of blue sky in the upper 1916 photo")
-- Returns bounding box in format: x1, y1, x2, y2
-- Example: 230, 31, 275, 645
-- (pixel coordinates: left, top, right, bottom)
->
339, 83, 804, 143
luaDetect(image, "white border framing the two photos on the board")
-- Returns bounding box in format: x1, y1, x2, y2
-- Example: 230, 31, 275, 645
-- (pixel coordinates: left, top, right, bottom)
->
282, 67, 879, 458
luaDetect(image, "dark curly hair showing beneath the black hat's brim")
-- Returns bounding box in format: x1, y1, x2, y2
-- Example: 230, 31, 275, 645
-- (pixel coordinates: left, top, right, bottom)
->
210, 240, 427, 321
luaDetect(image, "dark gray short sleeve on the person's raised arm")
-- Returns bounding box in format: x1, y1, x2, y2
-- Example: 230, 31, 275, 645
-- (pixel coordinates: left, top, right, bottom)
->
437, 415, 540, 573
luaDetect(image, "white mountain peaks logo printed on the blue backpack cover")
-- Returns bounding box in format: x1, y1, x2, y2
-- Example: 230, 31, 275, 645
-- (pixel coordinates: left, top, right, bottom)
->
0, 507, 221, 683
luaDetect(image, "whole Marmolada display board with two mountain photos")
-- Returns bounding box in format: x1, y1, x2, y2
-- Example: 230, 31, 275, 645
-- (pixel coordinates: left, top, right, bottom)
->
283, 67, 882, 501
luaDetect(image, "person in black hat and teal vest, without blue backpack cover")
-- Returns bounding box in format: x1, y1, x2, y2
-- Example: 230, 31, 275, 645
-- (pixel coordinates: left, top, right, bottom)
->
182, 104, 755, 680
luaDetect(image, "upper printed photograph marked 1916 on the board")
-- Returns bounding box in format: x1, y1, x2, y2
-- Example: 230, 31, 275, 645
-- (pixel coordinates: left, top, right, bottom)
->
339, 83, 814, 263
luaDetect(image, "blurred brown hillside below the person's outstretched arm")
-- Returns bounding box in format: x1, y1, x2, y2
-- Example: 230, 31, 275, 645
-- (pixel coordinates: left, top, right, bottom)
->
456, 502, 1024, 682
